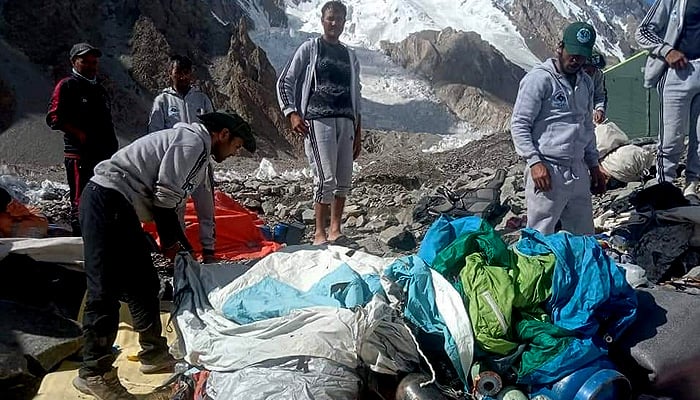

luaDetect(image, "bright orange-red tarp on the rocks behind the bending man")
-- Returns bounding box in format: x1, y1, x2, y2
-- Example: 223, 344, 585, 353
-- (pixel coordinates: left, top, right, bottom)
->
144, 191, 282, 260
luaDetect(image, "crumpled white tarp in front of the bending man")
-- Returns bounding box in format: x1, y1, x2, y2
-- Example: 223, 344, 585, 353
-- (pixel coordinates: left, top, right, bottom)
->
175, 246, 419, 373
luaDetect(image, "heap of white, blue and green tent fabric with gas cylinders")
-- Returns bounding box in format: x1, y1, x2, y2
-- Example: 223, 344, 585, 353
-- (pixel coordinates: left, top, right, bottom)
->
160, 215, 700, 400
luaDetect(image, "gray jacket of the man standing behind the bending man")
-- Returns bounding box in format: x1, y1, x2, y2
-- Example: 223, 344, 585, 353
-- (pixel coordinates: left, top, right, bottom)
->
148, 86, 214, 133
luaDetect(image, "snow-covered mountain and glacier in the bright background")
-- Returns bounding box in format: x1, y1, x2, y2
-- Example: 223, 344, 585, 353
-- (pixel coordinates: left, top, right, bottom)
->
227, 0, 647, 144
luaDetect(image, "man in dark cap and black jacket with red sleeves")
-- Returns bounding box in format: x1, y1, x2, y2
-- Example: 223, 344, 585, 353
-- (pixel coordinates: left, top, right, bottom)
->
46, 43, 118, 236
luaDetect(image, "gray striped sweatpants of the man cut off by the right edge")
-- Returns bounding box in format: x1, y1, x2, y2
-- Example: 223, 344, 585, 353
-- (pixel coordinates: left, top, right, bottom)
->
656, 60, 700, 182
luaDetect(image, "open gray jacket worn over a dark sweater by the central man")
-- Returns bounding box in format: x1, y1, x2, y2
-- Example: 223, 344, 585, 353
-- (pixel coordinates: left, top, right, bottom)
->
276, 37, 362, 122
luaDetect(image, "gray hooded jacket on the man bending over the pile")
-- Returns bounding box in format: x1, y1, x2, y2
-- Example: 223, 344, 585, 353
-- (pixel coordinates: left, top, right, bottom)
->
91, 123, 211, 222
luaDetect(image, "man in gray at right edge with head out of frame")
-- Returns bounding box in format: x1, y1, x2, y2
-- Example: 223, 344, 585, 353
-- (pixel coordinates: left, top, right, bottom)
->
636, 0, 700, 196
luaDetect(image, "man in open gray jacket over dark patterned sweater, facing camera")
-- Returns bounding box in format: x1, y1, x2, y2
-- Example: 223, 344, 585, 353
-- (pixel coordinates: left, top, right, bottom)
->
277, 1, 362, 245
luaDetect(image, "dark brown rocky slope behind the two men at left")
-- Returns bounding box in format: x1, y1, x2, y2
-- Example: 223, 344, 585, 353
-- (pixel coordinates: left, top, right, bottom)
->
0, 0, 294, 164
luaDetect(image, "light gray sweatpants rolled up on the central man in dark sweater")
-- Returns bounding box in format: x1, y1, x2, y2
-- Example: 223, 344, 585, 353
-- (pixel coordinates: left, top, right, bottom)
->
304, 118, 355, 204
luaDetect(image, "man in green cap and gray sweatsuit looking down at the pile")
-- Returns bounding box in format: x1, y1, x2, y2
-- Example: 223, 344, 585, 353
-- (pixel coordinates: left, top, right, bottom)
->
511, 22, 605, 235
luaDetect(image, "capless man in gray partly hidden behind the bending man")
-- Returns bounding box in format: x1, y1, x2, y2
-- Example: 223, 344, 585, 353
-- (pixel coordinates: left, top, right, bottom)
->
148, 55, 216, 263
